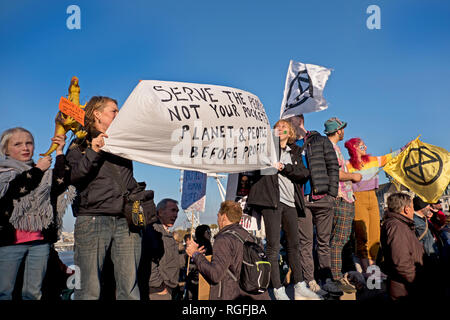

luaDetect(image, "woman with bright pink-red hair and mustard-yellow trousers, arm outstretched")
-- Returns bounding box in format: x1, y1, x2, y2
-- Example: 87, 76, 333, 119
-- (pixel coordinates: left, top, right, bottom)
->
345, 138, 406, 276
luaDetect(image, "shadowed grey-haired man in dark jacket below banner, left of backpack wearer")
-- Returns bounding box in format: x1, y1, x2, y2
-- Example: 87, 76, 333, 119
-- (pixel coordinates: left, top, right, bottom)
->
142, 199, 181, 300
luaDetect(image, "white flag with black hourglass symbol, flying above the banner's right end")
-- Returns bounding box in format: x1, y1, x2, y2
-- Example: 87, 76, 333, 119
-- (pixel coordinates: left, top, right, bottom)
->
280, 60, 331, 119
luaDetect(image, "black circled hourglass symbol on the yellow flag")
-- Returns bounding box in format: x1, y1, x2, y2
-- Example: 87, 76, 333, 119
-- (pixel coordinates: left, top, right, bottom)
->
403, 146, 443, 186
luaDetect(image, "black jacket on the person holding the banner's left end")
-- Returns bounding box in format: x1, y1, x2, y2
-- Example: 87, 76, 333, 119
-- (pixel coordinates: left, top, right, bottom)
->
66, 146, 139, 217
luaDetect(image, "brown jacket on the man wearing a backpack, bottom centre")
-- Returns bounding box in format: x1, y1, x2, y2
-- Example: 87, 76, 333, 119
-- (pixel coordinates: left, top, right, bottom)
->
194, 223, 251, 300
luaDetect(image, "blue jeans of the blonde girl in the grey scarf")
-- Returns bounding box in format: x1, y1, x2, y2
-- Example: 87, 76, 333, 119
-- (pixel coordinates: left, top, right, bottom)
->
0, 242, 50, 300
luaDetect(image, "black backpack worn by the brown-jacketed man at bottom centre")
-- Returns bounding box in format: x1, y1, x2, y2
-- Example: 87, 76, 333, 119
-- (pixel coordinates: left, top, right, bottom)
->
225, 231, 270, 294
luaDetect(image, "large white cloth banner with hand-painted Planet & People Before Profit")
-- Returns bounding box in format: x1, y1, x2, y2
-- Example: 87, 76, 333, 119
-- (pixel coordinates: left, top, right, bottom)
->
102, 80, 276, 173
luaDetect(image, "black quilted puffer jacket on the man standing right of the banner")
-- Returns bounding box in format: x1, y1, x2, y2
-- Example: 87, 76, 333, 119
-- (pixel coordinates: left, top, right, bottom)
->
304, 131, 339, 197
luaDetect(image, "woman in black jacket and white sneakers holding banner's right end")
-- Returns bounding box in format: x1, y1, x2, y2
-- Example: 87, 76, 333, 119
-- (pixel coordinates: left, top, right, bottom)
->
247, 120, 320, 300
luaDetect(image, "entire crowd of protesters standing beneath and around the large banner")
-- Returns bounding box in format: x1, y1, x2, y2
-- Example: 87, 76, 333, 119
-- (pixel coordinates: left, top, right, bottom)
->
0, 97, 450, 300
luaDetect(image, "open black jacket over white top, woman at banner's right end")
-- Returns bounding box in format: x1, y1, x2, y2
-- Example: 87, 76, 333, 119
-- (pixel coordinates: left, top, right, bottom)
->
247, 144, 309, 216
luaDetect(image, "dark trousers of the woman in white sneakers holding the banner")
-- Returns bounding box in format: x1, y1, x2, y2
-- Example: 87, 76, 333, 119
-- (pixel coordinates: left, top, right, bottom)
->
260, 203, 303, 289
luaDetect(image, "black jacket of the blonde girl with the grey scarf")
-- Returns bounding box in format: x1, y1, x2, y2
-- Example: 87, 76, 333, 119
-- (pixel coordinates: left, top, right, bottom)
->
0, 155, 70, 246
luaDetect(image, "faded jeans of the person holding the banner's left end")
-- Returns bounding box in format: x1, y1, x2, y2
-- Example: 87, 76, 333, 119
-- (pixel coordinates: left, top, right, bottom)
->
74, 216, 141, 300
